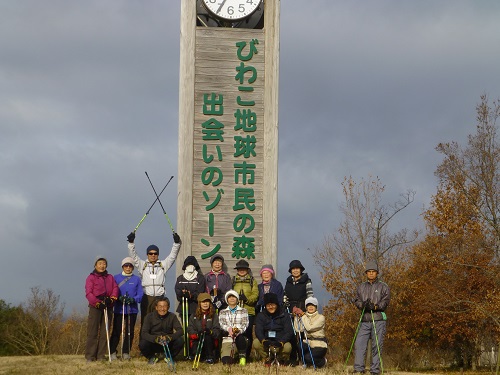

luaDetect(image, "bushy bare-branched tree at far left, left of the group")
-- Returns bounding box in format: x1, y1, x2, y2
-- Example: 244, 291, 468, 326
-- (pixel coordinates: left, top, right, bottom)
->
7, 286, 64, 355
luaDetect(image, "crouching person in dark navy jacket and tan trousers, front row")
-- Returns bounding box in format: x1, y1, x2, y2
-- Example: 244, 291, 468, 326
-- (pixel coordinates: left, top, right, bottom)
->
253, 293, 293, 364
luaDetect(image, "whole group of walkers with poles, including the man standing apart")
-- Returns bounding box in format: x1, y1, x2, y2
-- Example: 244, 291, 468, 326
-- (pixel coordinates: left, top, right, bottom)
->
85, 233, 390, 374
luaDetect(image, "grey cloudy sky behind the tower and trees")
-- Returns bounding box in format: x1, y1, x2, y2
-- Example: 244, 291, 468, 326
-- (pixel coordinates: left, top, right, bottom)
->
0, 0, 500, 312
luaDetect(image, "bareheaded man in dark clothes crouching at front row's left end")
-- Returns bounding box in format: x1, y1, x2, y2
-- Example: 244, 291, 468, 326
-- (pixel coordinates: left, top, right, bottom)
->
139, 297, 184, 365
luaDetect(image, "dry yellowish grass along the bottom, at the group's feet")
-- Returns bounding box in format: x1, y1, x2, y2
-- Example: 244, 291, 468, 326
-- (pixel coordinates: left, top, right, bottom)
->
0, 355, 465, 375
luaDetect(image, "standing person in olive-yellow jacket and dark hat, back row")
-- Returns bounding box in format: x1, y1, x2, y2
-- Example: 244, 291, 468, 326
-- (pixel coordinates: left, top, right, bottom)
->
232, 259, 259, 358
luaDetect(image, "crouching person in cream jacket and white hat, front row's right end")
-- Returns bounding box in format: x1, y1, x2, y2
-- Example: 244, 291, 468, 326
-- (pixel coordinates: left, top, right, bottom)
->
295, 297, 328, 368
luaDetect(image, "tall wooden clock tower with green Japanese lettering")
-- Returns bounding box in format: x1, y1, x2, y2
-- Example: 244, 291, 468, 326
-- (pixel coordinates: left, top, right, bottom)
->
177, 0, 279, 274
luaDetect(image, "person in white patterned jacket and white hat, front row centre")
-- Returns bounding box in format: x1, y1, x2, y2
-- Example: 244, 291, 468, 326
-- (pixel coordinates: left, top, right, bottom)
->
219, 290, 249, 366
